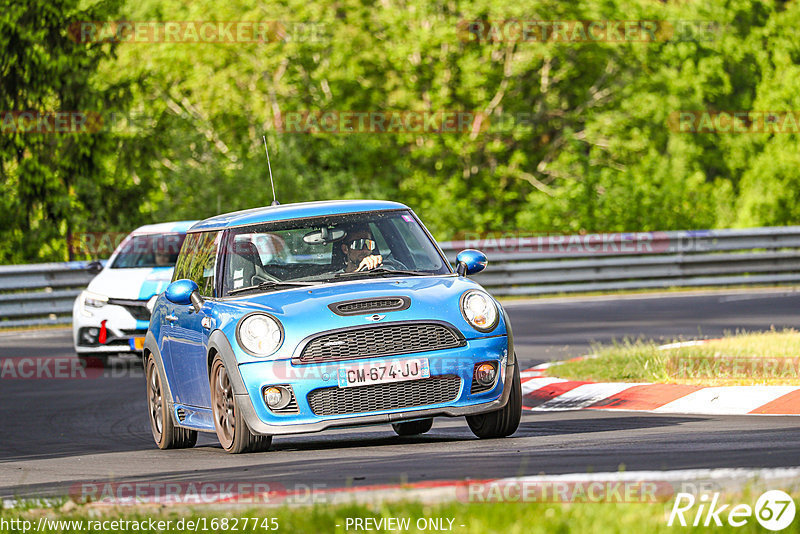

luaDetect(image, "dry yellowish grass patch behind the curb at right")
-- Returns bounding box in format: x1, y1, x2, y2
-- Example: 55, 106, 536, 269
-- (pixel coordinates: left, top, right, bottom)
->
550, 329, 800, 386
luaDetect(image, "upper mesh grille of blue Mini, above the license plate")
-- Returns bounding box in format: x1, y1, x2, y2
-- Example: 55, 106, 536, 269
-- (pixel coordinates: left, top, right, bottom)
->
295, 323, 464, 363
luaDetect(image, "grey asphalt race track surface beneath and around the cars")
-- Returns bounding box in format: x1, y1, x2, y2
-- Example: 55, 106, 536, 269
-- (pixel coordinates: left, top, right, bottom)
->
0, 290, 800, 498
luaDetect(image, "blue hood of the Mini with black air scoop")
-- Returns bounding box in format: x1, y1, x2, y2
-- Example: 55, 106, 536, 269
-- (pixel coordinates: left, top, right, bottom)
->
217, 276, 506, 357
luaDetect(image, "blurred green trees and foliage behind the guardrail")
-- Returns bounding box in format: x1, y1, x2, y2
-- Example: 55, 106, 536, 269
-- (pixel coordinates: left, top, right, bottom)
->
0, 0, 800, 264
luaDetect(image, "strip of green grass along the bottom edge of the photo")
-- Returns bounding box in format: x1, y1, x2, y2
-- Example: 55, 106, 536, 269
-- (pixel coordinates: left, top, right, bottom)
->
0, 499, 800, 534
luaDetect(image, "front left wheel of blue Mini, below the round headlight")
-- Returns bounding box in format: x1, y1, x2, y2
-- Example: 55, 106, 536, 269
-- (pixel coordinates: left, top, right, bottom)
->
210, 355, 272, 454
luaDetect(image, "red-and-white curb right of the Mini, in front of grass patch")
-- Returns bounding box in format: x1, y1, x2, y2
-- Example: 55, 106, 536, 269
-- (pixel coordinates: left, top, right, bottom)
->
521, 364, 800, 415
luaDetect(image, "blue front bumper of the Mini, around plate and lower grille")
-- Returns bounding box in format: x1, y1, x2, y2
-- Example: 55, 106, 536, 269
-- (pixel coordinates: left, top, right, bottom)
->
236, 336, 516, 435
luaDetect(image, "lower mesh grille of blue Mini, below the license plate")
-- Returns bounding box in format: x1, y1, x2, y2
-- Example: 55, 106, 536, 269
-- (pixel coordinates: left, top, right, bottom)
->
308, 375, 461, 416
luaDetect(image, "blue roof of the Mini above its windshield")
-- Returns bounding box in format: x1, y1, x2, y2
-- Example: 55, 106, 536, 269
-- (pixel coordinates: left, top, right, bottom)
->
191, 200, 408, 232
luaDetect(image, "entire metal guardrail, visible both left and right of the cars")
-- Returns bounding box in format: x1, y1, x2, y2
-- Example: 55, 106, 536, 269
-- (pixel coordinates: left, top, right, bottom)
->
0, 226, 800, 327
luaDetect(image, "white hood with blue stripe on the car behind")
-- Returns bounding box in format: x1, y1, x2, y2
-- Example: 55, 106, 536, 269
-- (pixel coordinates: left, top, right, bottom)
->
86, 267, 173, 300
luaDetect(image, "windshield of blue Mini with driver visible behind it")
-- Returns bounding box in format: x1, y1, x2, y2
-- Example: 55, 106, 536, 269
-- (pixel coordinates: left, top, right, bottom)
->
222, 210, 451, 295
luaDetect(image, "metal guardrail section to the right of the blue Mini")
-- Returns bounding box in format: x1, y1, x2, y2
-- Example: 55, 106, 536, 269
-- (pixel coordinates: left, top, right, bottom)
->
441, 226, 800, 296
